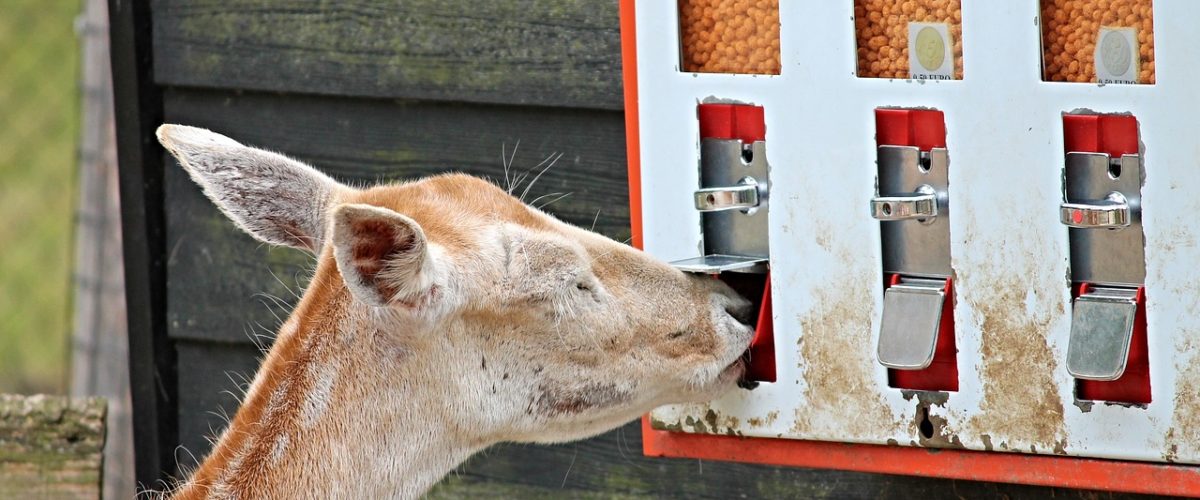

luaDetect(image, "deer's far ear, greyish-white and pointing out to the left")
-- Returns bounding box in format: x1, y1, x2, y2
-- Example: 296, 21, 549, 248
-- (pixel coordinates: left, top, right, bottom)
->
157, 125, 350, 253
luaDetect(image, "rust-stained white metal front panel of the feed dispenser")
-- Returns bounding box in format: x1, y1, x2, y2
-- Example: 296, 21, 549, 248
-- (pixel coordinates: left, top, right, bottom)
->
636, 0, 1200, 463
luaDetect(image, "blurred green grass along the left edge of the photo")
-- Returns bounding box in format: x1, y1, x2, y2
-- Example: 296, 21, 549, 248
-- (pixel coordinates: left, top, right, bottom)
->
0, 0, 80, 392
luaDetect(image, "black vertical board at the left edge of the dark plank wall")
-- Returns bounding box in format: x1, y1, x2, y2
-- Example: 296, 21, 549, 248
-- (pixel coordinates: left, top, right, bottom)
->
108, 0, 178, 486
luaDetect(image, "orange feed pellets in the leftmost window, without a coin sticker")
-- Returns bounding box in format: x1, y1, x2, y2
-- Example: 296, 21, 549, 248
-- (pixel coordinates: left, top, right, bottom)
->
679, 0, 780, 74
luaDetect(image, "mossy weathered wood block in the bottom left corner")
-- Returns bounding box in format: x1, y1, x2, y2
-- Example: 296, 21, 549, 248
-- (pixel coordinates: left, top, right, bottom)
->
0, 394, 107, 499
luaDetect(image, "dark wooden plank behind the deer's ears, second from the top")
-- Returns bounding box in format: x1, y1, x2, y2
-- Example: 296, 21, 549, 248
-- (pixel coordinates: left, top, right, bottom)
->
166, 90, 629, 342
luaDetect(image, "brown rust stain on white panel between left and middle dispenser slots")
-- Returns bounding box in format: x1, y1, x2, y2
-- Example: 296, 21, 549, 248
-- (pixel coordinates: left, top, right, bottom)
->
792, 276, 900, 439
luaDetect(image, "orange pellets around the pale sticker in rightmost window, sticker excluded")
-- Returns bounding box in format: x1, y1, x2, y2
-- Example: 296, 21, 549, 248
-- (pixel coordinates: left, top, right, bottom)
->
1042, 0, 1154, 84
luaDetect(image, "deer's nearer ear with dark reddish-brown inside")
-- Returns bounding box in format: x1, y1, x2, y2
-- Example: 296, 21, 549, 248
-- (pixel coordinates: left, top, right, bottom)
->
332, 204, 434, 307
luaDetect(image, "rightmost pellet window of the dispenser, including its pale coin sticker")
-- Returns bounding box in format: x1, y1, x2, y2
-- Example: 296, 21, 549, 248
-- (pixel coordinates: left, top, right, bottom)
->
1040, 0, 1154, 84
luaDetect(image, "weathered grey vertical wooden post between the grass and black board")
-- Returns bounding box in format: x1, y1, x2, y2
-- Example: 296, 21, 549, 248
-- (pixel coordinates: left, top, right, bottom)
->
71, 0, 136, 499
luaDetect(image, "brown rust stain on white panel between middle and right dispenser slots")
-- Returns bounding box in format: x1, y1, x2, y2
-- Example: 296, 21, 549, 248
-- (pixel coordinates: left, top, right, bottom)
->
965, 276, 1066, 448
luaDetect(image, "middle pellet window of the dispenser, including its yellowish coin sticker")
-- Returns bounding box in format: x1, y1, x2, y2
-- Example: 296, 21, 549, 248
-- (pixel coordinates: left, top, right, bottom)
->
853, 0, 962, 80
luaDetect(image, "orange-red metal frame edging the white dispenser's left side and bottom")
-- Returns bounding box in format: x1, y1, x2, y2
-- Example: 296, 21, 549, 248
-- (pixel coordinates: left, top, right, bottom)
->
620, 0, 1200, 498
